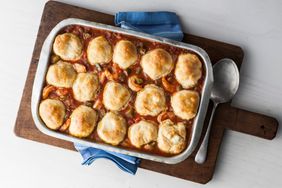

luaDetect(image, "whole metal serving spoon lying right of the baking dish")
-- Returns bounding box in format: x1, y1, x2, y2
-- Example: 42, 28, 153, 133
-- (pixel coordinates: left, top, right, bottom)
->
195, 58, 239, 164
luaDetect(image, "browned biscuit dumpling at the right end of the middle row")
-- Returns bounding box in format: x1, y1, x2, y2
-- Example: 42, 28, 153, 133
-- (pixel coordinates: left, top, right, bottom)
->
171, 90, 200, 120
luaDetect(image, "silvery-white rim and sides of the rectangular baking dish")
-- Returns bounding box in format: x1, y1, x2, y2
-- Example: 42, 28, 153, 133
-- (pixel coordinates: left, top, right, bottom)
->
31, 18, 213, 164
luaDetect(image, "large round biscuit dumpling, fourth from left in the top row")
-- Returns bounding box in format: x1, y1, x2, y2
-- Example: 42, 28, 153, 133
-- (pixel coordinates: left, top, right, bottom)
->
141, 48, 174, 80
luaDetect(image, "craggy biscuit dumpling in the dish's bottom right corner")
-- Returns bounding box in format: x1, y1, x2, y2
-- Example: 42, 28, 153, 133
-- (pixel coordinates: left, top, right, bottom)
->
157, 119, 186, 154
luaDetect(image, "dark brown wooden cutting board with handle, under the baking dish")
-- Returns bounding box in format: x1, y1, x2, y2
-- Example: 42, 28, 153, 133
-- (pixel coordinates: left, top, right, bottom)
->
15, 1, 278, 184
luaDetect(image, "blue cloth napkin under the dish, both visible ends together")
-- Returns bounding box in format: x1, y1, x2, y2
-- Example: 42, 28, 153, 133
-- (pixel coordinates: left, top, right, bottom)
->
74, 12, 183, 174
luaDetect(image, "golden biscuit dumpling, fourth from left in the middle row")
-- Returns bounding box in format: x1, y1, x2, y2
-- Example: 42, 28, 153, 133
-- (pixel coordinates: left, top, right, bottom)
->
135, 84, 166, 116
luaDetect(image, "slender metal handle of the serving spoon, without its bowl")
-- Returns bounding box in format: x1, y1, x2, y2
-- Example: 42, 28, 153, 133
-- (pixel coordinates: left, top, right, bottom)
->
195, 102, 218, 164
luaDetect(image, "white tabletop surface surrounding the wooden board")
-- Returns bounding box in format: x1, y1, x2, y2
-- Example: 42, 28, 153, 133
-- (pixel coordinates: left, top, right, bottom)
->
0, 0, 282, 188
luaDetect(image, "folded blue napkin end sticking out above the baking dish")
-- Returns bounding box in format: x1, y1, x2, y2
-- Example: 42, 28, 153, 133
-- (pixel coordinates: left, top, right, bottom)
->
115, 11, 183, 41
